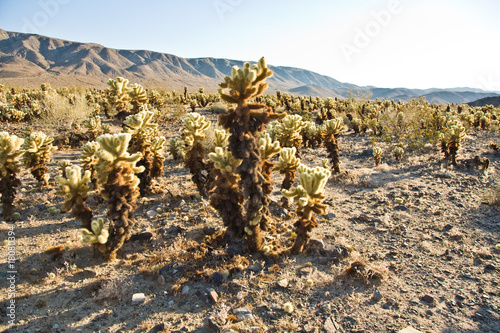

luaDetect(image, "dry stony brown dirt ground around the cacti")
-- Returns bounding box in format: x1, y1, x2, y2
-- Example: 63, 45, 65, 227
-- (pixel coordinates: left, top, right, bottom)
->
0, 112, 500, 333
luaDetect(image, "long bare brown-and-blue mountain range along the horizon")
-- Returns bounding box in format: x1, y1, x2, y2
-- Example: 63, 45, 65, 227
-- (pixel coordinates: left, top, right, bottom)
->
0, 29, 498, 103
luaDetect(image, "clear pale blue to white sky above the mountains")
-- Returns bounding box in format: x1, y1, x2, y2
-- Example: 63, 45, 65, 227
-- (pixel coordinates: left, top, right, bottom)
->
0, 0, 500, 91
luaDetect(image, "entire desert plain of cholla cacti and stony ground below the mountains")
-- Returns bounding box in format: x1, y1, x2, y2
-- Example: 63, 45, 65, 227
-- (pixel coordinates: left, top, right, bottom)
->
0, 58, 500, 332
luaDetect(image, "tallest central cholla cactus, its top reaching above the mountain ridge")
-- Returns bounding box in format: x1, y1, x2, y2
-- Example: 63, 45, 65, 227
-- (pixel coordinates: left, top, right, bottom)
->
219, 58, 284, 251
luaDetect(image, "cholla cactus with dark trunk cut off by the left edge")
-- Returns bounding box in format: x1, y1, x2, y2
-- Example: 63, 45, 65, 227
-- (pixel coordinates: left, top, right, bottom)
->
0, 132, 24, 220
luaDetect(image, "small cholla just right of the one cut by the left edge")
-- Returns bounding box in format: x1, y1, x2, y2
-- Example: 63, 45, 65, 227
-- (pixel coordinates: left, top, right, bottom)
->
22, 132, 57, 185
